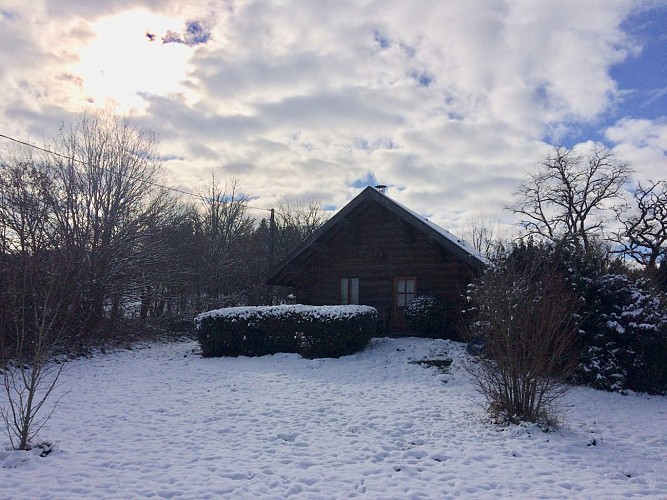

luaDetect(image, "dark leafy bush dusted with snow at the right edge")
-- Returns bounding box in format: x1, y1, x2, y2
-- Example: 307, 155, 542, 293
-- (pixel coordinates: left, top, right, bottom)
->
480, 241, 667, 393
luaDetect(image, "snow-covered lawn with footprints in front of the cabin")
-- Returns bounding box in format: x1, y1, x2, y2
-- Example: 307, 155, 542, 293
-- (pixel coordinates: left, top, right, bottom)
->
0, 338, 667, 499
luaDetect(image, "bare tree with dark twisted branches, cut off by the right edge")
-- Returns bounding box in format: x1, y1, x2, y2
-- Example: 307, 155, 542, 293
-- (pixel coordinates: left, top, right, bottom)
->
614, 180, 667, 274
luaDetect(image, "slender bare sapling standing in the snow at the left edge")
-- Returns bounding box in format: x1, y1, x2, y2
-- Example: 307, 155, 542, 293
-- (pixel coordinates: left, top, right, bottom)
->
0, 154, 74, 450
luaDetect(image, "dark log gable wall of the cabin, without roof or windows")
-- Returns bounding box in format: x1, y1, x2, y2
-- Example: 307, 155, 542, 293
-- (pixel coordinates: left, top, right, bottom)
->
294, 202, 474, 335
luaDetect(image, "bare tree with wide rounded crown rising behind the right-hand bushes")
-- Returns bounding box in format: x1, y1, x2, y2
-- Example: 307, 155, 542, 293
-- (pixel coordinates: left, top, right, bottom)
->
508, 147, 632, 249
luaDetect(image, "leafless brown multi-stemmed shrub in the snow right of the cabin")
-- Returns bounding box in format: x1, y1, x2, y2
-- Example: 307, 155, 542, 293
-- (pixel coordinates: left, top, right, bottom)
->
462, 255, 579, 425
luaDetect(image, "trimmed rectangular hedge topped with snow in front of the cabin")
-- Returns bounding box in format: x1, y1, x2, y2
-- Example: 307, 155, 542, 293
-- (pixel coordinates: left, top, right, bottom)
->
195, 305, 377, 358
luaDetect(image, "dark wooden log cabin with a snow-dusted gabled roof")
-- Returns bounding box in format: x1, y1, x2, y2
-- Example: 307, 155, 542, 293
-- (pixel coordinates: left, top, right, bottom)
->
267, 186, 485, 335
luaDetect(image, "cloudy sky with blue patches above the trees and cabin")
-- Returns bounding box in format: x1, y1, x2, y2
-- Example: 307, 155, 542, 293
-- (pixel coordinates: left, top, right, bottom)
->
0, 0, 667, 230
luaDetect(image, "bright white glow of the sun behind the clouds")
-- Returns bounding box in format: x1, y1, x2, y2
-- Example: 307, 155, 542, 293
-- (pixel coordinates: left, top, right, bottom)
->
73, 10, 192, 112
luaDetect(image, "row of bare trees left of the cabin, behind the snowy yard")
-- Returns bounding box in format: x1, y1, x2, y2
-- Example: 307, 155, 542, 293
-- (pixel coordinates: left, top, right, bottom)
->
0, 113, 325, 351
